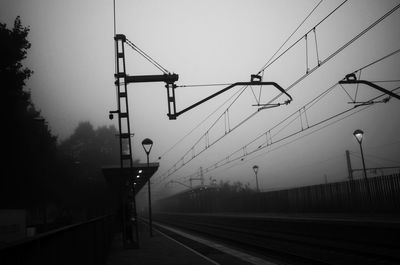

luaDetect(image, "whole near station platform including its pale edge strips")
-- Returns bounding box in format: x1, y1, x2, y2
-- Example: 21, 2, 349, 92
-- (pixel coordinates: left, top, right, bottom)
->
107, 219, 276, 265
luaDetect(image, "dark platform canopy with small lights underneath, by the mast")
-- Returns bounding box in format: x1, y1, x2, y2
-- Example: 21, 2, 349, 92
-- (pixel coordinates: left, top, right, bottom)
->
102, 163, 159, 194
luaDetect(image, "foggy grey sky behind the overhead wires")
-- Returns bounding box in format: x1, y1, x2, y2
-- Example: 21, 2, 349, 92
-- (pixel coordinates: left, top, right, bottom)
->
0, 0, 400, 197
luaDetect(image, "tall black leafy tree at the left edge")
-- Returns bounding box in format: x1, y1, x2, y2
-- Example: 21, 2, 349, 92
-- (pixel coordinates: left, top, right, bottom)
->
0, 17, 57, 208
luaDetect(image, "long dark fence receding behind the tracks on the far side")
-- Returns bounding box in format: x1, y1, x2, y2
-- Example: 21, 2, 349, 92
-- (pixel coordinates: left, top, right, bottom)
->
154, 174, 400, 213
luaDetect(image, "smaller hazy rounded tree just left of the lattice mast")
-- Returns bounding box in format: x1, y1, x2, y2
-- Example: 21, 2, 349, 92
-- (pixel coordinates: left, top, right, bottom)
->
59, 121, 126, 217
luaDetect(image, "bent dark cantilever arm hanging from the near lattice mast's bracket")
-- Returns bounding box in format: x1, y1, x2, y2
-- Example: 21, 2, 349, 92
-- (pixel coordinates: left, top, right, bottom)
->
168, 81, 293, 120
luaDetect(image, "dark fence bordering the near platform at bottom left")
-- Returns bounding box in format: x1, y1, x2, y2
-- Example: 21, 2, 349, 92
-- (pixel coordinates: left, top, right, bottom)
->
0, 215, 114, 265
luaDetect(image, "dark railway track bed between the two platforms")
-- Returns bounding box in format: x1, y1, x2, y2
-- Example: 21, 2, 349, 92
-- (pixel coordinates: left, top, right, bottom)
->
154, 213, 400, 265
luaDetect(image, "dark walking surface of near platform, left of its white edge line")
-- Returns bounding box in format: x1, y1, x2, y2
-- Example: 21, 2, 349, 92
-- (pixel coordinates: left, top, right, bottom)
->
107, 223, 217, 265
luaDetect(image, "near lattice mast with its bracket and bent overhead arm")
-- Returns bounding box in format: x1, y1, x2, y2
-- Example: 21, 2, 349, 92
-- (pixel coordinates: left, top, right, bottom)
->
109, 34, 292, 247
